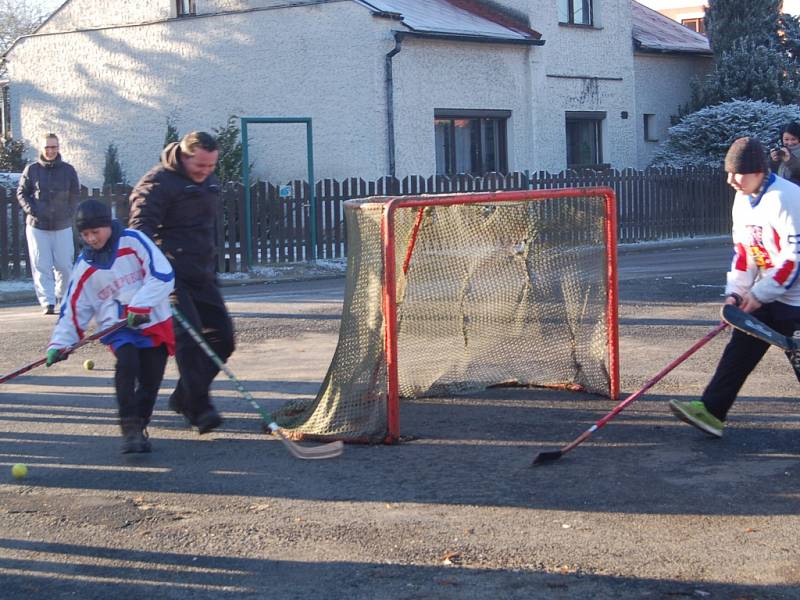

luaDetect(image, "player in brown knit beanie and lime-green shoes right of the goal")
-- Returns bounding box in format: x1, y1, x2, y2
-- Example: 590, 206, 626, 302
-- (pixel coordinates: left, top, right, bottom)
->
669, 137, 800, 437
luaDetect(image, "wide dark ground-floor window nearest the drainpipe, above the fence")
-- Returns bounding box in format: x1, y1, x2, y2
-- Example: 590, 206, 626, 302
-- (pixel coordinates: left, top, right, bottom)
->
433, 110, 510, 175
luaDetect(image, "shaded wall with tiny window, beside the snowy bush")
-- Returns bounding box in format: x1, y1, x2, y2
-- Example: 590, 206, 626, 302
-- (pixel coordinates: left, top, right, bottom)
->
634, 53, 712, 169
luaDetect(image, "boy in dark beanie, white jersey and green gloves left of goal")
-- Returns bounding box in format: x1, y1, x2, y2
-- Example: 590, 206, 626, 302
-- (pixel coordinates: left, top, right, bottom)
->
47, 200, 175, 453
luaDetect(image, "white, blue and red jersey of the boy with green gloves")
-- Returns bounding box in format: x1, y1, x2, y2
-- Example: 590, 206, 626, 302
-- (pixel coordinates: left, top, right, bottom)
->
49, 222, 175, 355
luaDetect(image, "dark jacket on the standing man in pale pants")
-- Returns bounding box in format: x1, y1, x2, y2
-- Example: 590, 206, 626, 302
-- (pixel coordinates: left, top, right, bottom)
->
17, 154, 80, 231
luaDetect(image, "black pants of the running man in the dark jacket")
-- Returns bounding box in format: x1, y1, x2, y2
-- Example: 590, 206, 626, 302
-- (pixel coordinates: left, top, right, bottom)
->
173, 281, 234, 420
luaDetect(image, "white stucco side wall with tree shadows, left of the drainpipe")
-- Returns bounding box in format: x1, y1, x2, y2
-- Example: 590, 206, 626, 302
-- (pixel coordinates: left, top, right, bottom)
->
9, 2, 393, 186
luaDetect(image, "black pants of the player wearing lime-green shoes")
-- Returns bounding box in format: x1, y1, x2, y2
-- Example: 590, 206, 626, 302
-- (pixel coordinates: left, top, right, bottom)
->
701, 302, 800, 421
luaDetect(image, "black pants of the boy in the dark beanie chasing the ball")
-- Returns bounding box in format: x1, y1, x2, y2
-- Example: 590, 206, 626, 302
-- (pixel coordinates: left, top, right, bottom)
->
114, 344, 167, 425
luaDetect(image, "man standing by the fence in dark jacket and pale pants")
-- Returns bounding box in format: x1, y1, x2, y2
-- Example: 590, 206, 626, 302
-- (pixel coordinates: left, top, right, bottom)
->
17, 133, 80, 315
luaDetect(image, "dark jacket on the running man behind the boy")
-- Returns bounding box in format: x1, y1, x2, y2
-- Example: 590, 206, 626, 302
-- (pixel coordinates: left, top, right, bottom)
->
128, 142, 220, 286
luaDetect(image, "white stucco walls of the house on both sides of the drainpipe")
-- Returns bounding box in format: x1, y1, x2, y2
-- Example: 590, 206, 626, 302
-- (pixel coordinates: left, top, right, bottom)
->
9, 0, 708, 186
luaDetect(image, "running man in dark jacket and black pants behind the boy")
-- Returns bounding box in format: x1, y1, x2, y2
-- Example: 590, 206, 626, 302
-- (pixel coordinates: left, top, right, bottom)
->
128, 131, 234, 433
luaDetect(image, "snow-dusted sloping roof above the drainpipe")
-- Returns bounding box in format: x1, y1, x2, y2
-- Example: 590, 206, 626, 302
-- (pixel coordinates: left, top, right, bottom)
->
356, 0, 541, 43
